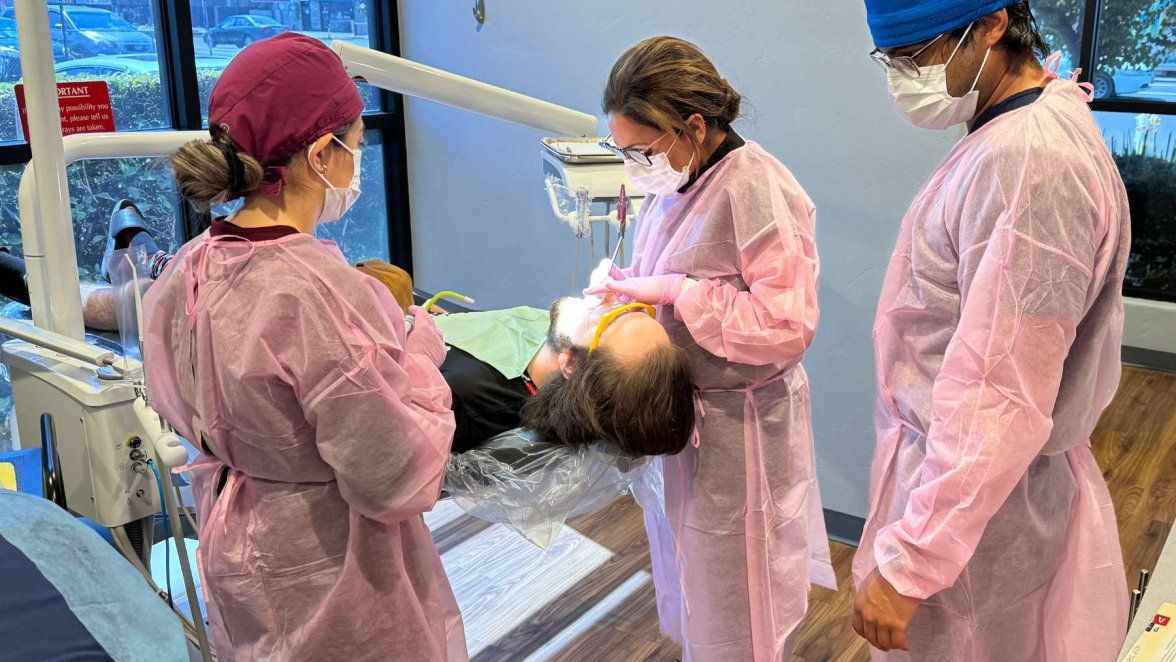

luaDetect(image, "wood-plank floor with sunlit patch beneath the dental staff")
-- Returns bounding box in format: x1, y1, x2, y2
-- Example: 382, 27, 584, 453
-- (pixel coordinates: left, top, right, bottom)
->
428, 368, 1176, 662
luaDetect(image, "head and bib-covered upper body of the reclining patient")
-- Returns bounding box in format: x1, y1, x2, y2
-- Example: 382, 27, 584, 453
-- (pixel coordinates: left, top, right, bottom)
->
435, 297, 694, 456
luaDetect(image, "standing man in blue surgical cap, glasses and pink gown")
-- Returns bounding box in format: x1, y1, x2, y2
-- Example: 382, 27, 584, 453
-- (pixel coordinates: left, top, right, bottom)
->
854, 0, 1130, 662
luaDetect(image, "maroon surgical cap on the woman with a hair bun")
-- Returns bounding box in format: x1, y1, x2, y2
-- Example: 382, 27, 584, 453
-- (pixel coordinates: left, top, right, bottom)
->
208, 32, 363, 196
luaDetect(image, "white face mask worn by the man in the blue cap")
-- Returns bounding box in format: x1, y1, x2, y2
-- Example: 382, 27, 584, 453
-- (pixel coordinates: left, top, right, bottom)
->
887, 25, 993, 131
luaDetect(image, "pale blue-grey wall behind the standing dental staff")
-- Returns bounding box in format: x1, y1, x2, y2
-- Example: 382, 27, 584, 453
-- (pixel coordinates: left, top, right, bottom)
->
399, 0, 956, 516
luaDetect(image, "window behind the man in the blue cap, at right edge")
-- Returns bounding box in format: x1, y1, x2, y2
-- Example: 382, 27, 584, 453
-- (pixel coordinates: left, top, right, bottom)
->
1031, 0, 1176, 301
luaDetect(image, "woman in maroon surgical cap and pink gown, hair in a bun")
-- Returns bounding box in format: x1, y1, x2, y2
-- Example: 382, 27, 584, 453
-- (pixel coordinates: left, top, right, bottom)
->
145, 33, 467, 661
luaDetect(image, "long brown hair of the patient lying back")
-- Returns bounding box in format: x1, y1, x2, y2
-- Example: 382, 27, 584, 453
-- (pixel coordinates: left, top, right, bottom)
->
522, 325, 694, 455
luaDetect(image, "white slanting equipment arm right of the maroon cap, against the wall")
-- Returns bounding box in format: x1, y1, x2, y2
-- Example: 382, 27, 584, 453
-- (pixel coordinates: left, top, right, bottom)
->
330, 41, 597, 136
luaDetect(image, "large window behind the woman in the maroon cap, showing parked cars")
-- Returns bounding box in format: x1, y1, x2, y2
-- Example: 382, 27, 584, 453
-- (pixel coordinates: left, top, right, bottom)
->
0, 0, 412, 450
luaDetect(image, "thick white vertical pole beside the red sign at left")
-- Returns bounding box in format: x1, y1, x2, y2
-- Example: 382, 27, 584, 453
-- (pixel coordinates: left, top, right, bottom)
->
16, 0, 86, 340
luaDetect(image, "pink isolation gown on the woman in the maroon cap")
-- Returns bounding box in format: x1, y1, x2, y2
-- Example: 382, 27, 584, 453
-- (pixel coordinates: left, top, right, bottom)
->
145, 233, 467, 661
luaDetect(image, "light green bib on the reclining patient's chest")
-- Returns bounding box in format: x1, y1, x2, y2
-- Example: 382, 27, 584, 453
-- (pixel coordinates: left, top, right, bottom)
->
433, 306, 552, 380
